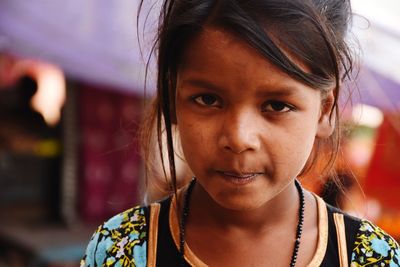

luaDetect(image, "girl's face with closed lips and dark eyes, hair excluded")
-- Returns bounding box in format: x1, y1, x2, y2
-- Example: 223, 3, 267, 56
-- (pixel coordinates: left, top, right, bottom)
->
176, 28, 333, 210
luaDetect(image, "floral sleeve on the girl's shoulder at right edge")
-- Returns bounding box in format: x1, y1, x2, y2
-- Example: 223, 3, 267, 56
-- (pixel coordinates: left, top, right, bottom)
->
351, 220, 400, 267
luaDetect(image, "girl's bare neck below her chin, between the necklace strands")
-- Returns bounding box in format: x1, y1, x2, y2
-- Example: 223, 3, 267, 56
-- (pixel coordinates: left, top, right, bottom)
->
188, 180, 299, 234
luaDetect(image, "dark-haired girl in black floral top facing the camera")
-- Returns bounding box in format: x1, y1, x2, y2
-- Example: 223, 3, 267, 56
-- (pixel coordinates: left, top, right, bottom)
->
82, 0, 400, 267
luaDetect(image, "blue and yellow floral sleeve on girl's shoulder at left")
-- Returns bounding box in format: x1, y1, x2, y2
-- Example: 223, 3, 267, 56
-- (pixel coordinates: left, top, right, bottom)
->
81, 206, 148, 267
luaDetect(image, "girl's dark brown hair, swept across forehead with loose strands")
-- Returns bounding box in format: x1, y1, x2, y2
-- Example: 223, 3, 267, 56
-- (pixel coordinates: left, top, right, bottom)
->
139, 0, 353, 201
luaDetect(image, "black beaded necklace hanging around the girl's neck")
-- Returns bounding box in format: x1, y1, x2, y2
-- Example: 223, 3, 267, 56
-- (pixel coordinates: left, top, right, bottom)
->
179, 178, 304, 267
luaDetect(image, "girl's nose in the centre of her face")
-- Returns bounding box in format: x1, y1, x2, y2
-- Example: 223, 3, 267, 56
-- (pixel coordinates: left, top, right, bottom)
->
218, 111, 260, 154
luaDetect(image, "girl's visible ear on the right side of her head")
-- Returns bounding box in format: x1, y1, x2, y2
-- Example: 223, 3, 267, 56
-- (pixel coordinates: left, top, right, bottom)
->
316, 90, 336, 139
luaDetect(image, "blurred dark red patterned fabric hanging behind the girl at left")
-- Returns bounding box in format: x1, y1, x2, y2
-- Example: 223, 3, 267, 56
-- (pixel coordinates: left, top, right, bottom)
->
78, 86, 142, 222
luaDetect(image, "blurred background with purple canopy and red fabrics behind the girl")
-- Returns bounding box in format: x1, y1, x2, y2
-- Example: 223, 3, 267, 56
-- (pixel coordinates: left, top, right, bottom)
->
0, 0, 400, 267
